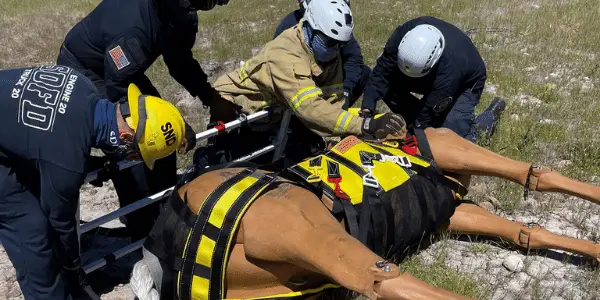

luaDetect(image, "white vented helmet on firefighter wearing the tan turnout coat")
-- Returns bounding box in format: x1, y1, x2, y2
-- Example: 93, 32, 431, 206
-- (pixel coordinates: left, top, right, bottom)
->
304, 0, 354, 42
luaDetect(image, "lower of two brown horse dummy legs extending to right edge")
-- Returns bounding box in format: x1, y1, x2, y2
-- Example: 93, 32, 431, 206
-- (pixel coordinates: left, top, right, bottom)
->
446, 203, 600, 262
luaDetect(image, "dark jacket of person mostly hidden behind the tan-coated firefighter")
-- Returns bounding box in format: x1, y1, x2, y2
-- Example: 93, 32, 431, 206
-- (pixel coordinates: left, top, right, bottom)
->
273, 9, 364, 93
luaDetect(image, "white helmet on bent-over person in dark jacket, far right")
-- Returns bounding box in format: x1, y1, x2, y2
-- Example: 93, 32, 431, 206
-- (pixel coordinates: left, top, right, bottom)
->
398, 24, 446, 77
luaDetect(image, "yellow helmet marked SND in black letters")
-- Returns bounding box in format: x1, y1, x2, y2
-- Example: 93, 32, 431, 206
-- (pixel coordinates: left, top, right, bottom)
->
121, 84, 185, 170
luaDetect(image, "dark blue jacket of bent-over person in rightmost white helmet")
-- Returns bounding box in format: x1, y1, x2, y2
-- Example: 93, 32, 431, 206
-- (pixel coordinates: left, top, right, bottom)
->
362, 17, 486, 113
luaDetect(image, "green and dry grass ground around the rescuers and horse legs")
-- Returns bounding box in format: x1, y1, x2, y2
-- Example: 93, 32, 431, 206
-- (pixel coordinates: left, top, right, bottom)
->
0, 0, 600, 295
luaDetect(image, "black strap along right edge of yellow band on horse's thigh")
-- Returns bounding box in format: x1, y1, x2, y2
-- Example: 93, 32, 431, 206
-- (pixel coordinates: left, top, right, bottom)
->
208, 174, 277, 299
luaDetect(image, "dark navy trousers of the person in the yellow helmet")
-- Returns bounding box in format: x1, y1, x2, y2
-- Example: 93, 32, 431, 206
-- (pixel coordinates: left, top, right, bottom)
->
0, 161, 72, 300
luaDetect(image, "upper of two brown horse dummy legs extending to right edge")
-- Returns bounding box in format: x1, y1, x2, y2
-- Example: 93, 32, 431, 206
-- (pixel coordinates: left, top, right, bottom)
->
425, 128, 600, 204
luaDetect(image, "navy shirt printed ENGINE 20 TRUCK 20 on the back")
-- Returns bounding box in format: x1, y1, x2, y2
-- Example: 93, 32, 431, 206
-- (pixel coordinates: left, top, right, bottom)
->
0, 66, 98, 263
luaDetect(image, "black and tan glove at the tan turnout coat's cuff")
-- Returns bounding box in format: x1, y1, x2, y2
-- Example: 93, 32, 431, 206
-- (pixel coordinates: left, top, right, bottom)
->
362, 113, 406, 139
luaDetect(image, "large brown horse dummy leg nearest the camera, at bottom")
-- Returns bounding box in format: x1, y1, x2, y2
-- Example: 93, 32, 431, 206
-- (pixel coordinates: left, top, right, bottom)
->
242, 184, 466, 300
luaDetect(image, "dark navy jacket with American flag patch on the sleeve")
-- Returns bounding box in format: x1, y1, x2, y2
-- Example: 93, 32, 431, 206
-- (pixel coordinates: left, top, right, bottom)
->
64, 0, 212, 102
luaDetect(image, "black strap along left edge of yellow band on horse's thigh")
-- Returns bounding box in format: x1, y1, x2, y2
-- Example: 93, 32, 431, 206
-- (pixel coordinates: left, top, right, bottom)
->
179, 168, 256, 300
